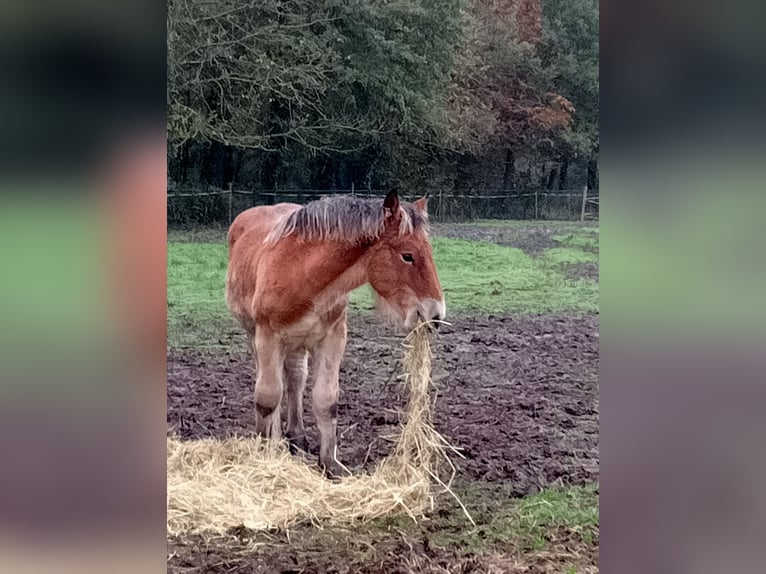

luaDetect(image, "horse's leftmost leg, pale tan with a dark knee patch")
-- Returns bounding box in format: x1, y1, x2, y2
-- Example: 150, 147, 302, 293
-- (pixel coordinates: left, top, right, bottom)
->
255, 328, 285, 440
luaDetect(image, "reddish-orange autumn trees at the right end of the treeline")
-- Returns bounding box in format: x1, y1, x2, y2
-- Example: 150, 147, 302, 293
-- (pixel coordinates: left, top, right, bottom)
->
438, 0, 598, 188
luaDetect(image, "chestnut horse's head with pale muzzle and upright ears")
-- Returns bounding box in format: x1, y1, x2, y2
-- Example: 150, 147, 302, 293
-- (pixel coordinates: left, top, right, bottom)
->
368, 191, 446, 329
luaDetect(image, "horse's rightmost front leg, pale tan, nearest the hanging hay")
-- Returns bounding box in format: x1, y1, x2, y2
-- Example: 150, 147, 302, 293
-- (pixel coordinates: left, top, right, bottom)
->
312, 313, 348, 477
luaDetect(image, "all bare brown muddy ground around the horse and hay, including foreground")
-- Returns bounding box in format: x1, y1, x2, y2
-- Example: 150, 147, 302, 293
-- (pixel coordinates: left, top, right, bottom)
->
167, 224, 599, 574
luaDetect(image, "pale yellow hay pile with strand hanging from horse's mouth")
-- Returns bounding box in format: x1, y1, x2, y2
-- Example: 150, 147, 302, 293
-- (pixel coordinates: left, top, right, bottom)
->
167, 324, 470, 536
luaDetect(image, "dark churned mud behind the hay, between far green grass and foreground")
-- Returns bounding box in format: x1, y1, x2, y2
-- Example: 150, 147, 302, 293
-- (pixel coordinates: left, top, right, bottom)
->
168, 316, 598, 496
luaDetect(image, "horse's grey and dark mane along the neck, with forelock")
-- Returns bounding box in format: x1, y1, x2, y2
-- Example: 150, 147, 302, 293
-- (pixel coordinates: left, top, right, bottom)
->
266, 195, 428, 243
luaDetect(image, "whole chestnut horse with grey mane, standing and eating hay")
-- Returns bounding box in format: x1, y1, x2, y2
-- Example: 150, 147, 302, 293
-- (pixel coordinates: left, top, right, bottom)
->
226, 191, 445, 476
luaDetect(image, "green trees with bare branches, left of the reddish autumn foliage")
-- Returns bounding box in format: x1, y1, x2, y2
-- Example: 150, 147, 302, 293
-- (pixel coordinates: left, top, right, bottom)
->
168, 0, 461, 151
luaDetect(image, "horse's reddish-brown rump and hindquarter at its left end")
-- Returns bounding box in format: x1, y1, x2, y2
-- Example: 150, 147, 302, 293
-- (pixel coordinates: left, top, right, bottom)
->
226, 203, 301, 330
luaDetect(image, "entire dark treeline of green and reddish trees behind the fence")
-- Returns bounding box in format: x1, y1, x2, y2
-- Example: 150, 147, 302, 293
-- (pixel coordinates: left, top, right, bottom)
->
168, 0, 598, 202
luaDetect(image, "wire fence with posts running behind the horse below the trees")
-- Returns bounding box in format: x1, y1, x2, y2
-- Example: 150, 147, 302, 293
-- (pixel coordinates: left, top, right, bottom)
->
168, 186, 599, 227
